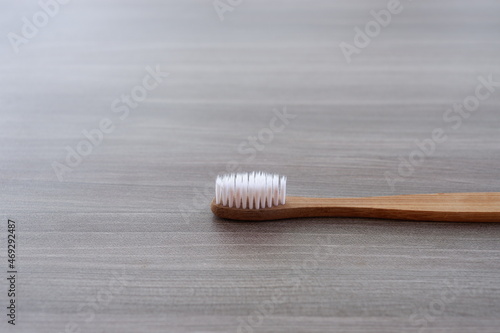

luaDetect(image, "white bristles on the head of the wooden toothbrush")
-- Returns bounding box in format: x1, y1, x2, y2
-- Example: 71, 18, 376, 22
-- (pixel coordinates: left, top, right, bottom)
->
215, 172, 286, 209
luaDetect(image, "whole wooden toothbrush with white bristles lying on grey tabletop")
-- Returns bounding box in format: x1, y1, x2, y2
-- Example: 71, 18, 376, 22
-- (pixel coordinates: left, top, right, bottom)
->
211, 172, 500, 222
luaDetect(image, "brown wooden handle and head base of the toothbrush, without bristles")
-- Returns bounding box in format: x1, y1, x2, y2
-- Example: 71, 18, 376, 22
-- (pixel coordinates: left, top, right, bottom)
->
212, 192, 500, 222
